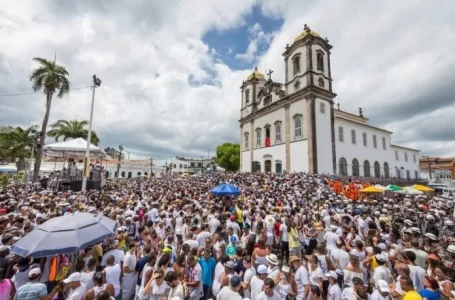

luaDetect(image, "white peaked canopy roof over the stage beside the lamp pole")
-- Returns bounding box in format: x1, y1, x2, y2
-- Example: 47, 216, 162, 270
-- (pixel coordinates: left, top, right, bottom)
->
43, 138, 106, 158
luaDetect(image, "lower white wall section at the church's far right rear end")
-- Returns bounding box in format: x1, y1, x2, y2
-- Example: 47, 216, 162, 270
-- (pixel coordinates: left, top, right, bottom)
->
391, 146, 420, 179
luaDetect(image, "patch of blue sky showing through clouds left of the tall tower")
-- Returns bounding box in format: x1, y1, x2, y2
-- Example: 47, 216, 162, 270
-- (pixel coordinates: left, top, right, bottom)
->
202, 6, 284, 70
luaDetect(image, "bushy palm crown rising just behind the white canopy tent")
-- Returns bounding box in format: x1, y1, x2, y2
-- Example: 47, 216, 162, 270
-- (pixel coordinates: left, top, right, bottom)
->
47, 120, 100, 146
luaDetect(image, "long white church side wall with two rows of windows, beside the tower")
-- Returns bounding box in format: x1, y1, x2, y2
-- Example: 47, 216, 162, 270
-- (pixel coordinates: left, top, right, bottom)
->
335, 119, 393, 177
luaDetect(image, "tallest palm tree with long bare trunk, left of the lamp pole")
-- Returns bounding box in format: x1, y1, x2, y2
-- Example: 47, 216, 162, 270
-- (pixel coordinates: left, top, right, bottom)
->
30, 57, 71, 181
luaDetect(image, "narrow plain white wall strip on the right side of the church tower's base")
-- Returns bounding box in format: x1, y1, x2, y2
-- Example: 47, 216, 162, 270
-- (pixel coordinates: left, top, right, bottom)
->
315, 99, 333, 174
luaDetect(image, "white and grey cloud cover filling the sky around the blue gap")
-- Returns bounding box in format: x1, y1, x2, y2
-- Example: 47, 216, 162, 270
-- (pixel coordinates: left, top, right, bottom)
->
0, 0, 455, 159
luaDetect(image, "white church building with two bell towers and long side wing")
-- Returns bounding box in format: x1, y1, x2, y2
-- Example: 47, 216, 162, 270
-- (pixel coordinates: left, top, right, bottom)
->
239, 25, 420, 179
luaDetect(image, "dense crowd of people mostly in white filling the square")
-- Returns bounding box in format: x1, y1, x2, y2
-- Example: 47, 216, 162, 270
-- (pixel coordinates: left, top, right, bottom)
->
0, 173, 455, 300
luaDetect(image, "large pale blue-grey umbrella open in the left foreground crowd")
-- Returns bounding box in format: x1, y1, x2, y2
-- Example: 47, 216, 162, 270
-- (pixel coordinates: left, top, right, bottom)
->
11, 213, 117, 258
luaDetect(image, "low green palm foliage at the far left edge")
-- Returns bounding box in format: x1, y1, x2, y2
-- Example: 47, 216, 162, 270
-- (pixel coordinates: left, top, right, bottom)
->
0, 125, 38, 171
